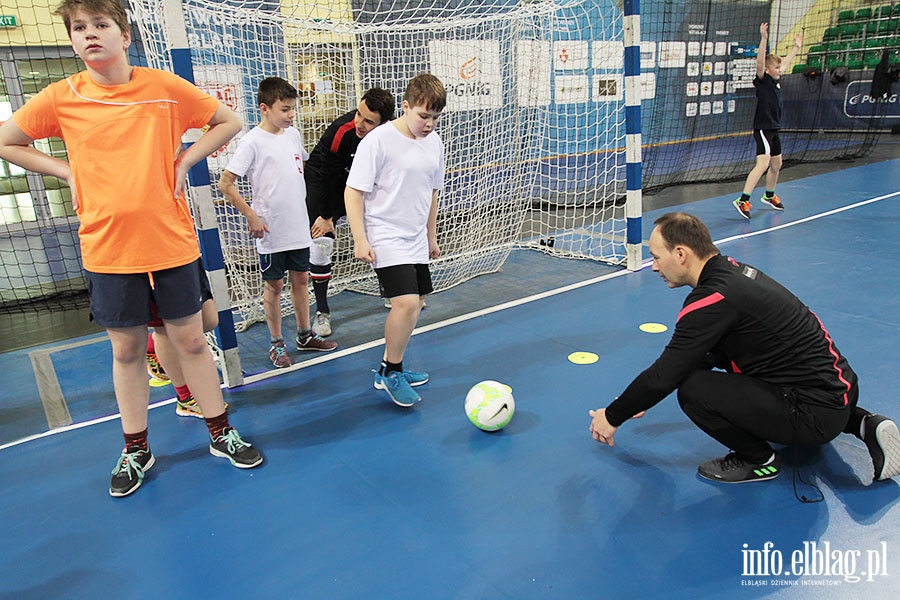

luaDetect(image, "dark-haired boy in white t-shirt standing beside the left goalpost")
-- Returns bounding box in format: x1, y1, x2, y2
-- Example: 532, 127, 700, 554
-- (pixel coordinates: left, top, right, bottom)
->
219, 77, 337, 368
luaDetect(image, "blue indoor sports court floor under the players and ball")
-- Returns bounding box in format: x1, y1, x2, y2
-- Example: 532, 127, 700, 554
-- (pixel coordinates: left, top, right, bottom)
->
0, 154, 900, 600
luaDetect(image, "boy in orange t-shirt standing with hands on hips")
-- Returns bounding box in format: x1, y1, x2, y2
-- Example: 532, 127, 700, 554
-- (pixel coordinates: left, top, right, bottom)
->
0, 0, 263, 497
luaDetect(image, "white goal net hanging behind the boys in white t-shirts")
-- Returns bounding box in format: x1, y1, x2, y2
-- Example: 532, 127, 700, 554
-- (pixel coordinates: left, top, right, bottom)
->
130, 0, 625, 330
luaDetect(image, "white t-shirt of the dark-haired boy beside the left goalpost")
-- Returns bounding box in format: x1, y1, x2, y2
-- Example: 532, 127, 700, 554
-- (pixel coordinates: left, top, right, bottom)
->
225, 126, 312, 254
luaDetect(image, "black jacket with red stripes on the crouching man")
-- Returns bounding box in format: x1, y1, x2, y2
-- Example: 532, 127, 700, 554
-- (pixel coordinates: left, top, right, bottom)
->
606, 255, 857, 427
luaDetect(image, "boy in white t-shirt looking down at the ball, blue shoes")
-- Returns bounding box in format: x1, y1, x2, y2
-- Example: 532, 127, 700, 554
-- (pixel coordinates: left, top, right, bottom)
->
344, 73, 447, 406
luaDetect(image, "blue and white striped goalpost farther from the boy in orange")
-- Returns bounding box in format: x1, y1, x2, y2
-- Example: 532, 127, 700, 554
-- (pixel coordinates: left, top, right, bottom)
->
622, 0, 643, 271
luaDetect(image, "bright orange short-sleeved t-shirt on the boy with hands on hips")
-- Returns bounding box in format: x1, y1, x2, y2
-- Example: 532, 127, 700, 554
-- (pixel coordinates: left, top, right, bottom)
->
13, 67, 219, 273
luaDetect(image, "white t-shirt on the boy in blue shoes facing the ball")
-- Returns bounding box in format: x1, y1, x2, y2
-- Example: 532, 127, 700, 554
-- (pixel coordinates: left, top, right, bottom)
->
347, 123, 444, 268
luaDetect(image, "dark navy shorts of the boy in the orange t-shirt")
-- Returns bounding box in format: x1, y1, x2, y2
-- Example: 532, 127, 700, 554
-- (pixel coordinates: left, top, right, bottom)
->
85, 258, 206, 328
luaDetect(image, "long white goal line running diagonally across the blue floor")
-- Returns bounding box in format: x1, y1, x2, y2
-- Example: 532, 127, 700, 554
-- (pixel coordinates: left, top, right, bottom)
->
0, 191, 900, 450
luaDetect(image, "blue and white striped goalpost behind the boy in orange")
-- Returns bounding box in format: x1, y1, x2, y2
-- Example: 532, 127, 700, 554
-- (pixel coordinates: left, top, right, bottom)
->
164, 0, 244, 387
